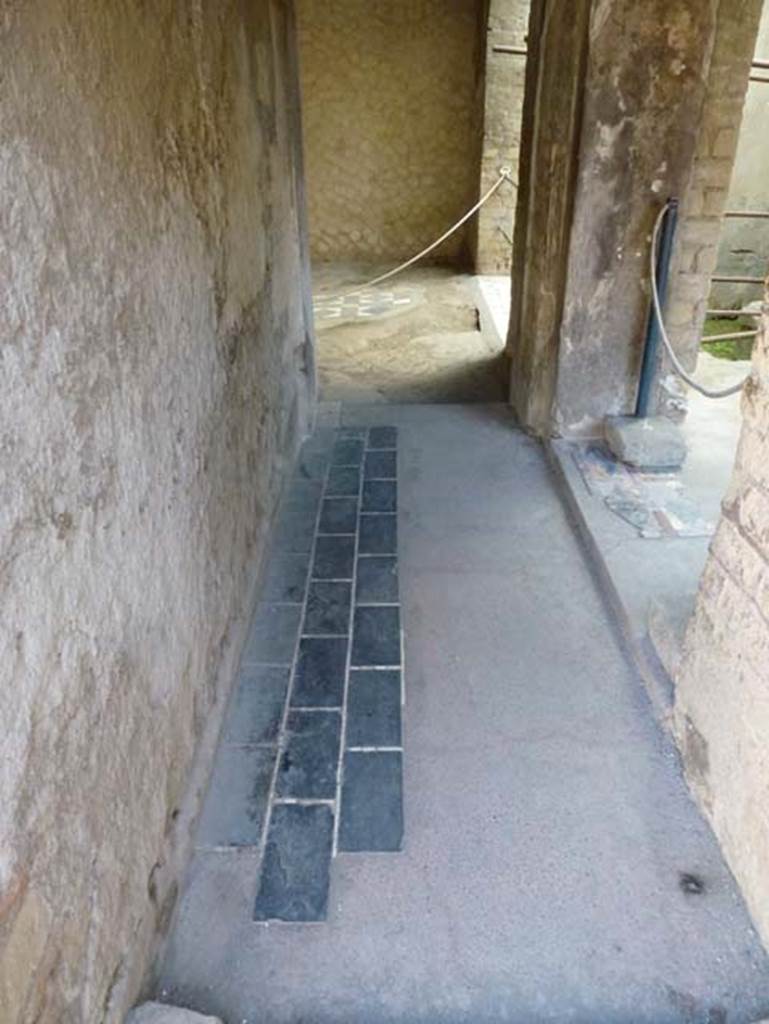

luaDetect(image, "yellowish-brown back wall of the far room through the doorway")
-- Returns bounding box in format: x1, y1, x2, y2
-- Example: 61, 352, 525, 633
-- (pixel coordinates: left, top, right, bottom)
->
297, 0, 484, 263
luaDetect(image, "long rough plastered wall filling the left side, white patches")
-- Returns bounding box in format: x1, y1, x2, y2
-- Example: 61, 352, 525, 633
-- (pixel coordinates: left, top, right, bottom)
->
0, 0, 311, 1024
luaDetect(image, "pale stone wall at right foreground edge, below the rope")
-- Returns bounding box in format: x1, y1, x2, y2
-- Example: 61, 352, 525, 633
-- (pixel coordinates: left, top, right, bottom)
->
675, 278, 769, 944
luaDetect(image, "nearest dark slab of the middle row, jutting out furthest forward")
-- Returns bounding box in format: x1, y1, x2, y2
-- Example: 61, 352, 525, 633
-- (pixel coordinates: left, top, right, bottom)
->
254, 804, 334, 922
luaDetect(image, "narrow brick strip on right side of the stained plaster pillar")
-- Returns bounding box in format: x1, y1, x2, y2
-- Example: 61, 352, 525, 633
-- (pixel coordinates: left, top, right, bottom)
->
660, 0, 766, 387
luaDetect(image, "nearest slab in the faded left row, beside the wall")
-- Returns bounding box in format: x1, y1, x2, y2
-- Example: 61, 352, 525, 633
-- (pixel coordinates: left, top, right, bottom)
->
198, 746, 276, 846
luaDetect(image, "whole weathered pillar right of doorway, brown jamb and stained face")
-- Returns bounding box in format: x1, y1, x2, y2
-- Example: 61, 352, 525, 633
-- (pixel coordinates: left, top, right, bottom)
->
510, 0, 760, 435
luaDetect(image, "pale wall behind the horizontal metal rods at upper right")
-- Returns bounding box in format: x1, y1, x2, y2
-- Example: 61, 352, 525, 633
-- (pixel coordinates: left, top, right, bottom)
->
712, 2, 769, 308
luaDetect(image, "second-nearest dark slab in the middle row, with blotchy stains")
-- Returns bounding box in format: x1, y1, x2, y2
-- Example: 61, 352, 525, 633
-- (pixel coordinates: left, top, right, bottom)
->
277, 711, 342, 800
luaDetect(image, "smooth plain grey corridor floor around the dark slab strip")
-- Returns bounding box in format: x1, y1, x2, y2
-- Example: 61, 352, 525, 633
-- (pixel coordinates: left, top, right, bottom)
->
158, 404, 769, 1024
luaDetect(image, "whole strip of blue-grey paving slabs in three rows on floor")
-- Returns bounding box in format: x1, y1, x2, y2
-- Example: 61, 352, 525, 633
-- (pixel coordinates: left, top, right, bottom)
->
199, 427, 403, 921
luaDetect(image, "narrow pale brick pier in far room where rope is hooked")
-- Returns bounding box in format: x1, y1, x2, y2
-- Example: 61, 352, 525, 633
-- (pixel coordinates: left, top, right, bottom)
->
475, 0, 529, 273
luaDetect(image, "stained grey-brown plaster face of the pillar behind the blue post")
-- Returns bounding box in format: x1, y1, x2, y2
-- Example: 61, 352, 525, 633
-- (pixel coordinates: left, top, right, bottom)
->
554, 0, 717, 435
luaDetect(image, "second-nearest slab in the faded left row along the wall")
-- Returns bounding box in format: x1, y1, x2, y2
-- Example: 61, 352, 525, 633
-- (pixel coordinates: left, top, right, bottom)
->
224, 666, 291, 743
